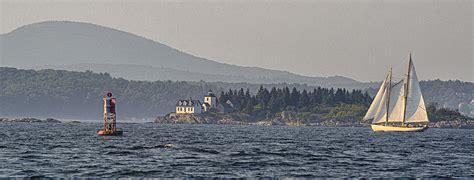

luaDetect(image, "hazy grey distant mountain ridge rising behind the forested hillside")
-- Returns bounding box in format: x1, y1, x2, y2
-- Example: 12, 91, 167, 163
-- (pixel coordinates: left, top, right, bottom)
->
0, 21, 360, 87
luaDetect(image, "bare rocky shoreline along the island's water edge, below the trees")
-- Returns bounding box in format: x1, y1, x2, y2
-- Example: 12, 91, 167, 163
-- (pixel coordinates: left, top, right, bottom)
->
154, 113, 474, 129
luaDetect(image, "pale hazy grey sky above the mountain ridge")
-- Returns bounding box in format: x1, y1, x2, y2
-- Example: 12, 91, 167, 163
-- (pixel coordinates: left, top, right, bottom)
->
0, 0, 474, 81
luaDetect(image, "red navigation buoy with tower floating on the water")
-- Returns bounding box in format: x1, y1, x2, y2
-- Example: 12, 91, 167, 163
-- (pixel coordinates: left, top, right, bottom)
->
97, 92, 123, 136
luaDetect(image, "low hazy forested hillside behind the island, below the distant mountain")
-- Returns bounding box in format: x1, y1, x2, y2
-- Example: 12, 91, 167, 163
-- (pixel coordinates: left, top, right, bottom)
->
0, 67, 474, 119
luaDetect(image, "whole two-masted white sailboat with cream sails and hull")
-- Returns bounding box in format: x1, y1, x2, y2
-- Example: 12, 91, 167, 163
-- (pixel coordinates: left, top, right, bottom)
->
364, 53, 429, 132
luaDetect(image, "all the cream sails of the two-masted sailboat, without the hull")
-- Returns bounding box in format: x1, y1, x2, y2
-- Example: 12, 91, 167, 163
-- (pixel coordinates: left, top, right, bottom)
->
364, 55, 428, 124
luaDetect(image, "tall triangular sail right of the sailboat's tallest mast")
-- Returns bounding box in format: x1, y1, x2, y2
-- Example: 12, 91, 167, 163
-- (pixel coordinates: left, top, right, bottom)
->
405, 61, 429, 123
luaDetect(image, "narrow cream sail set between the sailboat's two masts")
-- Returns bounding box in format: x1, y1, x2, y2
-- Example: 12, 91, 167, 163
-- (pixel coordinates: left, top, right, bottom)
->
388, 80, 405, 122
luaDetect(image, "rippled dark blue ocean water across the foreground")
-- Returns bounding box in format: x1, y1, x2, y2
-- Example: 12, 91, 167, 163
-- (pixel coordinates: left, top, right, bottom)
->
0, 123, 474, 178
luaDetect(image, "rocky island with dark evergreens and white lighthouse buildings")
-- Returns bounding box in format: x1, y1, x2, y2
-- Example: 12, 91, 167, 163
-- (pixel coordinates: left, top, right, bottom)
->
155, 87, 474, 128
